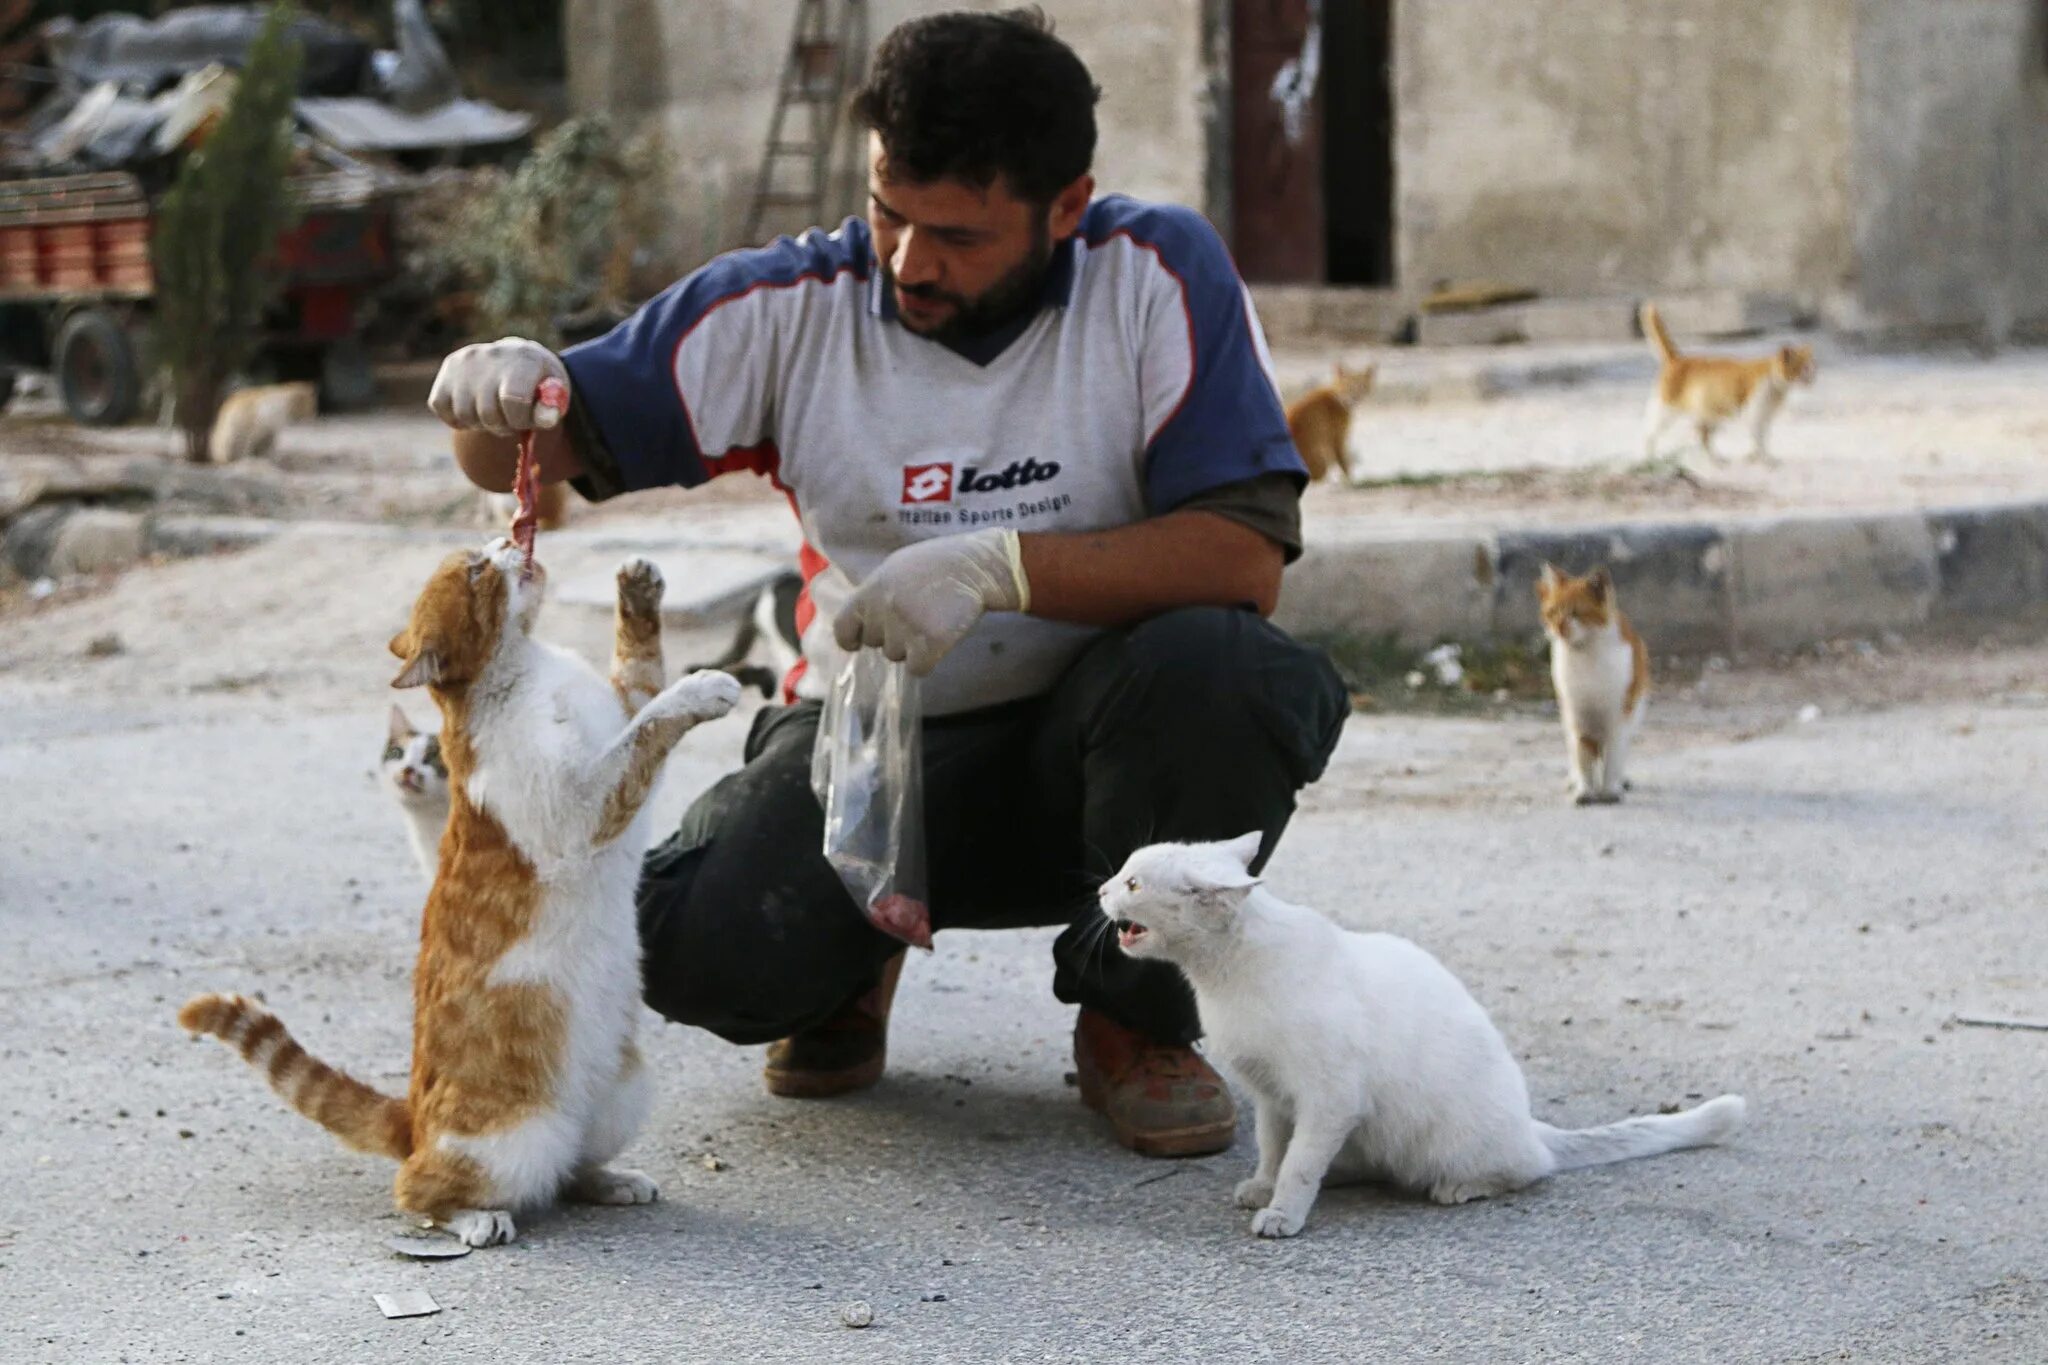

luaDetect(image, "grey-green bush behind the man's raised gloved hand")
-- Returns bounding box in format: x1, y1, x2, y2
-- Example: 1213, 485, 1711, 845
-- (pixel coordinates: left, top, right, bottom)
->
420, 117, 651, 346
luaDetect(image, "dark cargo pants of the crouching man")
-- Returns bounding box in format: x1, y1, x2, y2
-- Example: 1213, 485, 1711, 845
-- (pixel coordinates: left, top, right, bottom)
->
639, 608, 1350, 1044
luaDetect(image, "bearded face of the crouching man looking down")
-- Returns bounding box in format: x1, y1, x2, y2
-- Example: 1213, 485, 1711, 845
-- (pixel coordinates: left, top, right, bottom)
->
868, 137, 1094, 340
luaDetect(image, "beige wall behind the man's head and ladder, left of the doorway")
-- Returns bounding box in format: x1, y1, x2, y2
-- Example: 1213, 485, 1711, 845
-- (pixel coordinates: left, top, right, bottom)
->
565, 0, 1206, 270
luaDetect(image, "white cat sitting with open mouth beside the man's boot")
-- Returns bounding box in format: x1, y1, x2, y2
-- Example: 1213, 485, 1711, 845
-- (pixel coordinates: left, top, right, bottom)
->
1100, 833, 1745, 1236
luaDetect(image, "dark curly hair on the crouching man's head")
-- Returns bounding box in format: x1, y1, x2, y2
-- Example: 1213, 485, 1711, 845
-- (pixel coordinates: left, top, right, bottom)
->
852, 6, 1102, 205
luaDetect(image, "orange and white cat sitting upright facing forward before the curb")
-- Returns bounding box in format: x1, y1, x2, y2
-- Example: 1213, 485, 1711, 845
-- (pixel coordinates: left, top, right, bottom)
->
1536, 565, 1651, 806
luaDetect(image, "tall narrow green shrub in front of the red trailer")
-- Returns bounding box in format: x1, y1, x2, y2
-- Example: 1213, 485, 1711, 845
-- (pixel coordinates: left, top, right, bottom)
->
152, 4, 301, 460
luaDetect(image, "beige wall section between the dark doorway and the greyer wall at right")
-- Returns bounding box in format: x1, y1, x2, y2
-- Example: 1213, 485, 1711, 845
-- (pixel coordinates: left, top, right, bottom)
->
1395, 0, 1859, 295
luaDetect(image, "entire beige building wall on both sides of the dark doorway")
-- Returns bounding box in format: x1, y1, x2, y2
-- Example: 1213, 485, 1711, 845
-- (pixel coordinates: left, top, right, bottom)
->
567, 0, 2048, 336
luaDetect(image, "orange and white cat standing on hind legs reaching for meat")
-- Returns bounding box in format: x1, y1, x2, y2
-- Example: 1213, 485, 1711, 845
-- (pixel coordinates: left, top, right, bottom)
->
178, 540, 739, 1246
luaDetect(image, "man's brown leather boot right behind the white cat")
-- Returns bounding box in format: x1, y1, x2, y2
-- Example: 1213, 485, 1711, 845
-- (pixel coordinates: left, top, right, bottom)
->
1073, 1009, 1237, 1156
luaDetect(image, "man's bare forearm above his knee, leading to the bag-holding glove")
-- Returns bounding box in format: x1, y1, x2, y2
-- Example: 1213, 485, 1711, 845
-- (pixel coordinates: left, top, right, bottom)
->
1018, 512, 1286, 626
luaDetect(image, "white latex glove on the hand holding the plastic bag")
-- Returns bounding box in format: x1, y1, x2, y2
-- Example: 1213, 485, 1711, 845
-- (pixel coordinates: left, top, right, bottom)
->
831, 530, 1030, 677
